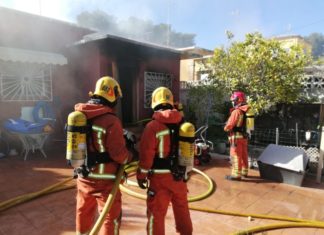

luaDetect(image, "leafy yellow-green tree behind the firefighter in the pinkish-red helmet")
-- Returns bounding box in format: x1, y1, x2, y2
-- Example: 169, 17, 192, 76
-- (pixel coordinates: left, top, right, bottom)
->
206, 33, 310, 114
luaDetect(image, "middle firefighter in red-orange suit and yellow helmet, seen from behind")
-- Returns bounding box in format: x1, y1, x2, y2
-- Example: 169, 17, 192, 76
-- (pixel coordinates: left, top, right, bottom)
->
137, 87, 193, 235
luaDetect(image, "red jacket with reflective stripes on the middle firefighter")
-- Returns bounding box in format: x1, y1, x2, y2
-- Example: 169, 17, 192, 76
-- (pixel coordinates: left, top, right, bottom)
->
139, 109, 182, 177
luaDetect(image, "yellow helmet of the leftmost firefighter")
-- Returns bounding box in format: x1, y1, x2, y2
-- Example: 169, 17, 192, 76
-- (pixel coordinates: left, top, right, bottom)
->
89, 76, 123, 103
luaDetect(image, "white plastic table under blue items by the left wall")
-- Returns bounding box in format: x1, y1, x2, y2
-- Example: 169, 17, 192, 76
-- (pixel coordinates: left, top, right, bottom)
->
11, 131, 50, 161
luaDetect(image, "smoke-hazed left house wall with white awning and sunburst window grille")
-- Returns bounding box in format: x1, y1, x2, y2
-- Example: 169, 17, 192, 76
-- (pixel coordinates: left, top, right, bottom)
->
0, 7, 93, 134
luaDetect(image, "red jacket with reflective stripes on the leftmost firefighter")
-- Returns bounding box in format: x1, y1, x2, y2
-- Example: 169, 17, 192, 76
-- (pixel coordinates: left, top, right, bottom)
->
74, 103, 131, 174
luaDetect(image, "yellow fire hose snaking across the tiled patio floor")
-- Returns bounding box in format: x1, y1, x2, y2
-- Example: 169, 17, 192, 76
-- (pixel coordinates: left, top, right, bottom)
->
0, 163, 324, 235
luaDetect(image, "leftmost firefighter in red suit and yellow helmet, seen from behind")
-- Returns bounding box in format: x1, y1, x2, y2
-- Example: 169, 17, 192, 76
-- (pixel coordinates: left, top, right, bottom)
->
70, 76, 132, 235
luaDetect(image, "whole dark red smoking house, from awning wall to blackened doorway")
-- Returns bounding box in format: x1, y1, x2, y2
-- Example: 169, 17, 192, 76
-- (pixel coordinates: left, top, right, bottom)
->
0, 7, 181, 140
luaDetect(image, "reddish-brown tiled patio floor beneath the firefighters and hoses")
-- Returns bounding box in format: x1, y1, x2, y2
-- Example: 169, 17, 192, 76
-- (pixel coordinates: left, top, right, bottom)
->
0, 142, 324, 235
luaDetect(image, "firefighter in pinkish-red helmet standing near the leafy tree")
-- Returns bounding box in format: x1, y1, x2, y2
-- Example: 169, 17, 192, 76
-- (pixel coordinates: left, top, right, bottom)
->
224, 91, 249, 180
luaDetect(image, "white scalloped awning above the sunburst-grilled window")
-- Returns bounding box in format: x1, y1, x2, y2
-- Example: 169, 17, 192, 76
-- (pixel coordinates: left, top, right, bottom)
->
0, 47, 67, 65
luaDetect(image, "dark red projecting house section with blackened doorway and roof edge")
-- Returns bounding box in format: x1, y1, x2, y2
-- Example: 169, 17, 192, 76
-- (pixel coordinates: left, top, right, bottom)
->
69, 33, 180, 124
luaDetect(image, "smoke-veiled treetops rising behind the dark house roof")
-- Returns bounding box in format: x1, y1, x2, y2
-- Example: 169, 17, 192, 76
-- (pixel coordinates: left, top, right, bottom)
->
77, 10, 196, 47
